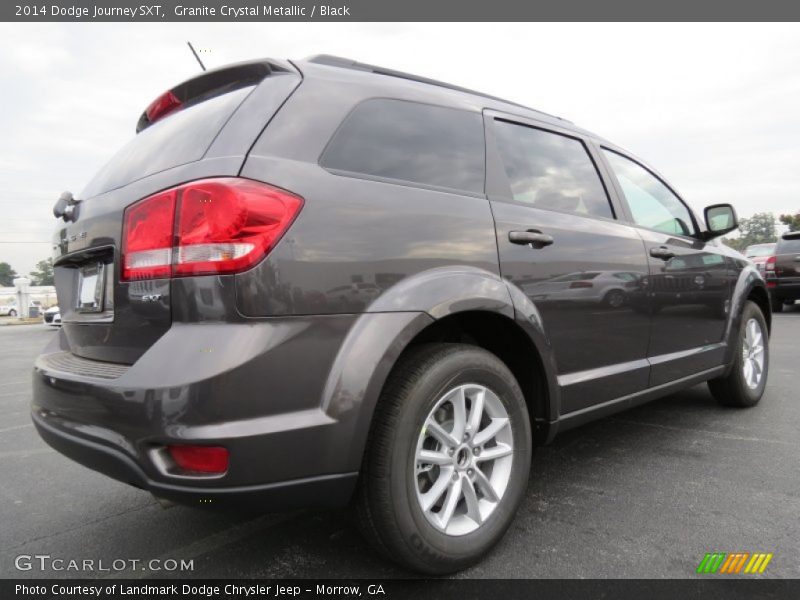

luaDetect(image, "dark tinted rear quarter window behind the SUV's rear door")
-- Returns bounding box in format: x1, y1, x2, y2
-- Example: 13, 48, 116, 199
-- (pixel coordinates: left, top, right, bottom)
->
320, 99, 485, 194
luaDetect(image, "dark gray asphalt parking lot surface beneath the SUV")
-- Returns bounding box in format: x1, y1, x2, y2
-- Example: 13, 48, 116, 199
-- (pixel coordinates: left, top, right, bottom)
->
0, 316, 800, 578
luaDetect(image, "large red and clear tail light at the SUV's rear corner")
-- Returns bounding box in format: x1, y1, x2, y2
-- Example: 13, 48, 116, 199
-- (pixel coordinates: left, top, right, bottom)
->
122, 177, 303, 281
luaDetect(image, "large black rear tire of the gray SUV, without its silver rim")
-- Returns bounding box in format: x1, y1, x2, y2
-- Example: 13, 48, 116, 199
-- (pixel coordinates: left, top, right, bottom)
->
356, 344, 531, 575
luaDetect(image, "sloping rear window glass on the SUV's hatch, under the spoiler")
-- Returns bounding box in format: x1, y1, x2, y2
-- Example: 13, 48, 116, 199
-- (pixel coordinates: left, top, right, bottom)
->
81, 86, 253, 198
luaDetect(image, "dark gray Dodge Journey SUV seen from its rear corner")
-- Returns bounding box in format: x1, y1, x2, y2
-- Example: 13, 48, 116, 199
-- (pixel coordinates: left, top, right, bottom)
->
32, 56, 771, 573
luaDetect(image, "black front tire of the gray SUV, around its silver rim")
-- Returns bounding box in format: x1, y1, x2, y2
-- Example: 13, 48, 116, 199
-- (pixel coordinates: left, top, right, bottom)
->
708, 300, 774, 408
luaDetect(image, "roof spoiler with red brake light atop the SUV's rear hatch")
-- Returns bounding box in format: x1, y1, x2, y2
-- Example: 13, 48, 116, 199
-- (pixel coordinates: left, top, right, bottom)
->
136, 61, 286, 133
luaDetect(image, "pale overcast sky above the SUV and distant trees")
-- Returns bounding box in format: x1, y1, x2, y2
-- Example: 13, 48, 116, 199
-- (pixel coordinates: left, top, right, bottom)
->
0, 23, 800, 274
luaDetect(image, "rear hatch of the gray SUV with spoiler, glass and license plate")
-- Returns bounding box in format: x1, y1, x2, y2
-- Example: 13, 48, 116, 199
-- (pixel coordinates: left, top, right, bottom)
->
53, 61, 300, 364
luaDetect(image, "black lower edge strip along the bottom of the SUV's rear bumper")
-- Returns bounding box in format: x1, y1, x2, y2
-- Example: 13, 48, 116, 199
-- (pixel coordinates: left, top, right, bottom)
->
32, 413, 358, 511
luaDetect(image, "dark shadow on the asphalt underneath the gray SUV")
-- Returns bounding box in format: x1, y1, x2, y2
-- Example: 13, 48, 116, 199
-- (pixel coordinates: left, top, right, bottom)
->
142, 386, 756, 578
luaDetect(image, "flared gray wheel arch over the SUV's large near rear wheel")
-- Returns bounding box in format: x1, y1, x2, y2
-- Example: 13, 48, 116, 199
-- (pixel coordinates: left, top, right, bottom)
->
321, 266, 558, 470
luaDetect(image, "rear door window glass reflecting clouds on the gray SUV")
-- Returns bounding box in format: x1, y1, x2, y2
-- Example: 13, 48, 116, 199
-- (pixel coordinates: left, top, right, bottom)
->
488, 120, 614, 218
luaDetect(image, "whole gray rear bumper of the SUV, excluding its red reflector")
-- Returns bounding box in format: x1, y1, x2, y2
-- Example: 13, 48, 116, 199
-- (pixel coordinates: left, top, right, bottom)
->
32, 315, 388, 510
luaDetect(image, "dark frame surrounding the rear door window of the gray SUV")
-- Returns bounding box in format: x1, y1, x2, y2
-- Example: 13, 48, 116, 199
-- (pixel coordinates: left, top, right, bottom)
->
484, 108, 624, 223
